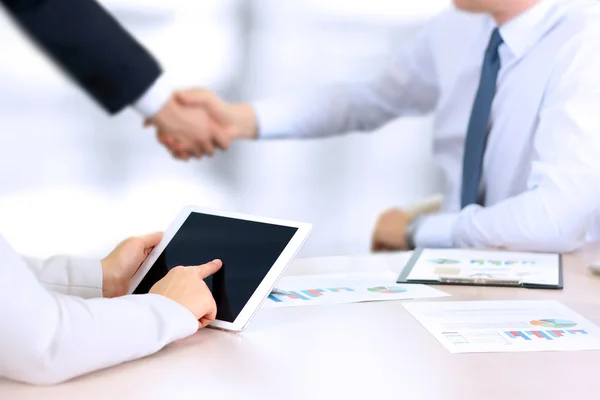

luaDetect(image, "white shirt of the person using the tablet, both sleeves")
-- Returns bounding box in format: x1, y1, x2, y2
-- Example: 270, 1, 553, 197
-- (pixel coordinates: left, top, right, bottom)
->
0, 236, 198, 384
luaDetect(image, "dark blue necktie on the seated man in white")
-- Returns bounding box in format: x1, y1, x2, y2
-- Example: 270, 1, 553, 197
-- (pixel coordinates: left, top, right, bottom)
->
461, 28, 503, 207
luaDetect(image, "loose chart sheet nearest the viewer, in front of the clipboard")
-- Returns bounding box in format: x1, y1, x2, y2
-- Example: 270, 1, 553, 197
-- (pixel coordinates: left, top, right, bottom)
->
404, 301, 600, 353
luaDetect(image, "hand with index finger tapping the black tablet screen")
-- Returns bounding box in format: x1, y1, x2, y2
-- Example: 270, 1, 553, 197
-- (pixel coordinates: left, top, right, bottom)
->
150, 260, 223, 328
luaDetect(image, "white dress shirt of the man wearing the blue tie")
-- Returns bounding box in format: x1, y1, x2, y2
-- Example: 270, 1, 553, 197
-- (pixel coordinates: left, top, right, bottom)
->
255, 0, 600, 251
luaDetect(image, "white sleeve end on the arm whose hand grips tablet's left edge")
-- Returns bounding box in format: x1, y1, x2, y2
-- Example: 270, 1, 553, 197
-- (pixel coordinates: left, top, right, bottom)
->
23, 256, 102, 298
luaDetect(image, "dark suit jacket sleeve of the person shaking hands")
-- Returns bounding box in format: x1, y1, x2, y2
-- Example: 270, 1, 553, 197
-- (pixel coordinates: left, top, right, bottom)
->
0, 0, 162, 113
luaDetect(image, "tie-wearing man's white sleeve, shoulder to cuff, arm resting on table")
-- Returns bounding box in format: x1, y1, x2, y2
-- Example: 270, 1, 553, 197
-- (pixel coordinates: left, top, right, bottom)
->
415, 32, 600, 252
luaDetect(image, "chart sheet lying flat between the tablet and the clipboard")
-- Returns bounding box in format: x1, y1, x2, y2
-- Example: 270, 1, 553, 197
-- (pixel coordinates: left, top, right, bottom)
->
264, 271, 449, 307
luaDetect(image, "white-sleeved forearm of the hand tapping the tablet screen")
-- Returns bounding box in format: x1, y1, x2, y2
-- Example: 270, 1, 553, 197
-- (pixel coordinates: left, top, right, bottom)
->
0, 290, 198, 384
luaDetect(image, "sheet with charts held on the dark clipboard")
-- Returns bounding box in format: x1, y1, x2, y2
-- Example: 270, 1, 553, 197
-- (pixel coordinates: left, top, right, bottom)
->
400, 249, 560, 285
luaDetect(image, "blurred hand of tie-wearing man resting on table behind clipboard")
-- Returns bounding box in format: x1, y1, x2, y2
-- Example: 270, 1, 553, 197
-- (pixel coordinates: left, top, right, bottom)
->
371, 209, 414, 252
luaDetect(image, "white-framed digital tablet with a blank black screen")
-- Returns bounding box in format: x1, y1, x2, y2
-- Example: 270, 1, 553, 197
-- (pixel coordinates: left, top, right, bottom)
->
129, 207, 312, 331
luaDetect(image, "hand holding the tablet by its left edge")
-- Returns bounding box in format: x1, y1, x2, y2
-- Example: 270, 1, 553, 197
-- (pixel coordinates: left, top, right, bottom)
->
101, 232, 162, 297
